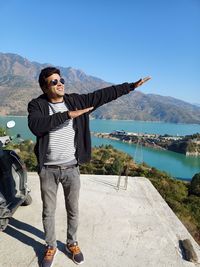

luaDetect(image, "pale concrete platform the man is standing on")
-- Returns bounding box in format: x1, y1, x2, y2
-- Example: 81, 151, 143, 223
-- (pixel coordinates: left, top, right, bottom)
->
0, 173, 200, 267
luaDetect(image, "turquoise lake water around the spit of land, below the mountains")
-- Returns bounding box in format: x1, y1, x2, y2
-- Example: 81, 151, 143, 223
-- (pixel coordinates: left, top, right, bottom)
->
0, 117, 200, 179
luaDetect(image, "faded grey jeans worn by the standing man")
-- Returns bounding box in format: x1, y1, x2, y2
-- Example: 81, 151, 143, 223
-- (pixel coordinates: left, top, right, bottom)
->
39, 166, 80, 247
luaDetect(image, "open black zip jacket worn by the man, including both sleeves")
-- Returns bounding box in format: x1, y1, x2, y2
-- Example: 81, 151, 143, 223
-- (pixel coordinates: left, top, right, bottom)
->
28, 83, 135, 172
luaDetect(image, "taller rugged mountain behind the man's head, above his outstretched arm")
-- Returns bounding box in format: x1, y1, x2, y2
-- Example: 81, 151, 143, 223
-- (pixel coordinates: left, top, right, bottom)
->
0, 53, 108, 115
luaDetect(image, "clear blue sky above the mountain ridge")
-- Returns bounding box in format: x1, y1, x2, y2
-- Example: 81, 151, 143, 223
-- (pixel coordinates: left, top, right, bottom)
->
0, 0, 200, 103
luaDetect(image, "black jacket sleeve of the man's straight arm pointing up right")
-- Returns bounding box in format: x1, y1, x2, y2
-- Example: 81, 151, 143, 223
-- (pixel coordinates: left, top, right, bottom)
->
76, 83, 135, 111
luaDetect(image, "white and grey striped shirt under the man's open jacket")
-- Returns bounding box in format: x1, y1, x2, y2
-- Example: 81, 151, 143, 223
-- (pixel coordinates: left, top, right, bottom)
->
44, 102, 76, 165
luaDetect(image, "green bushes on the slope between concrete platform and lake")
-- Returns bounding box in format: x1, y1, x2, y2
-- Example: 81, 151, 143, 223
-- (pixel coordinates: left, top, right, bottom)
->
0, 137, 200, 244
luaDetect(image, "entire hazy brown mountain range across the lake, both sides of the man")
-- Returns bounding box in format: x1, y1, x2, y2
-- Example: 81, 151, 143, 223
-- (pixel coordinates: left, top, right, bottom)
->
0, 53, 200, 123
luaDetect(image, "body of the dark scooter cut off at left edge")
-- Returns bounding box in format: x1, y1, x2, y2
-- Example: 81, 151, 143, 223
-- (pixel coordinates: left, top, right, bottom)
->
0, 148, 32, 231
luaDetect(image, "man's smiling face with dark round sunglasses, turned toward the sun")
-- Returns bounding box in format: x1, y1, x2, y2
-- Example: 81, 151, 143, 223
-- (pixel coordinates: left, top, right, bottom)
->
44, 73, 65, 101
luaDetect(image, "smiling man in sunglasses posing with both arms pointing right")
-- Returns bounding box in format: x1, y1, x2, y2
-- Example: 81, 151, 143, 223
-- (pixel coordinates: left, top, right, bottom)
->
28, 67, 150, 267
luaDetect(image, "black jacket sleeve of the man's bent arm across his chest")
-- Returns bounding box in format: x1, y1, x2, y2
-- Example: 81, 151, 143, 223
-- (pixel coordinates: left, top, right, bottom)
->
28, 99, 69, 137
